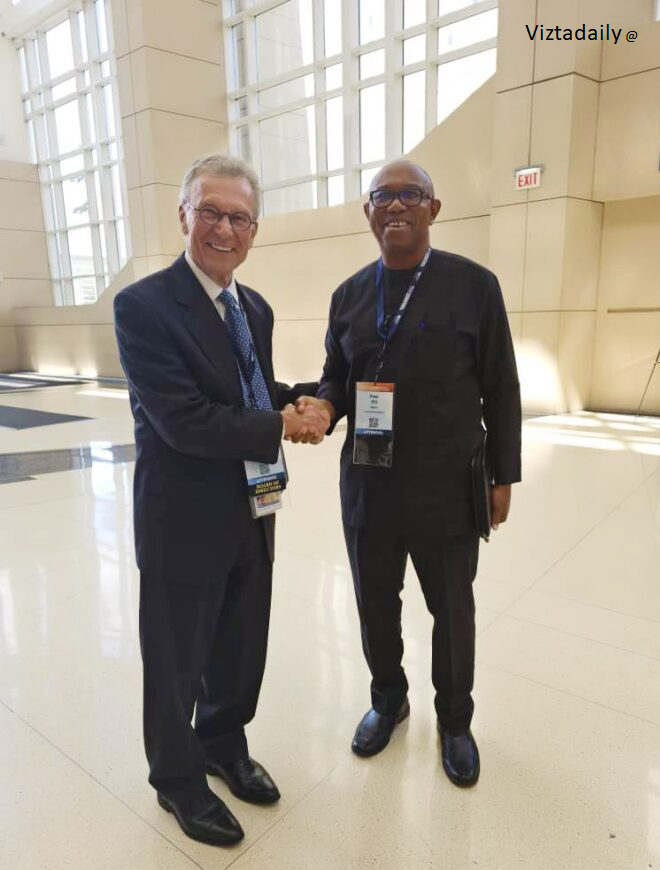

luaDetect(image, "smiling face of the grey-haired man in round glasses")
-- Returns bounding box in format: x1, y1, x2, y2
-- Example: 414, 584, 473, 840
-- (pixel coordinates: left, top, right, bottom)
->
179, 175, 257, 287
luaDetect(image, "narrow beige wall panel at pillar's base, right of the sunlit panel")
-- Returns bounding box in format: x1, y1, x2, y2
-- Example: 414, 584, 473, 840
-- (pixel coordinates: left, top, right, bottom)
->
557, 311, 596, 411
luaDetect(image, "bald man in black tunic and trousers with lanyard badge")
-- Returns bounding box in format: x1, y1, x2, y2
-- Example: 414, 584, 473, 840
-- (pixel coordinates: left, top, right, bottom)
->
298, 161, 521, 786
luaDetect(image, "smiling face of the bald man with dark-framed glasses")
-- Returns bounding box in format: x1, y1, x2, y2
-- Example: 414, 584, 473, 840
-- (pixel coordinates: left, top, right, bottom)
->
364, 161, 440, 269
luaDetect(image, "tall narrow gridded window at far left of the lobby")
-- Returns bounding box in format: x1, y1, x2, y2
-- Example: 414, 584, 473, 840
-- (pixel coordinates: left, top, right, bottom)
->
18, 0, 129, 305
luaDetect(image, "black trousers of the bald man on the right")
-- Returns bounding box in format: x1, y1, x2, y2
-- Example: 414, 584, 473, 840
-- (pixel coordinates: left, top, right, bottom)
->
344, 523, 479, 733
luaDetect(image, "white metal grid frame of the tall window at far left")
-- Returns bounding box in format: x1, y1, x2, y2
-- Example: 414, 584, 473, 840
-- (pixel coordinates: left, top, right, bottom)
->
16, 0, 130, 305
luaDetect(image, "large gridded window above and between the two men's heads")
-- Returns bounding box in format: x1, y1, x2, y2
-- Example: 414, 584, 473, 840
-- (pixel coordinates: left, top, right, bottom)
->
224, 0, 497, 214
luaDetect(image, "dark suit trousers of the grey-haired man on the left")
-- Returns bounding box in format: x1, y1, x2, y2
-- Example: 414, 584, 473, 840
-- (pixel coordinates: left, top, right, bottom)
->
140, 510, 272, 799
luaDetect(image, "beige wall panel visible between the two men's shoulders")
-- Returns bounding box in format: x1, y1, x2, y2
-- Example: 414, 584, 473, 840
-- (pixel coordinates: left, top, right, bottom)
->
236, 233, 378, 320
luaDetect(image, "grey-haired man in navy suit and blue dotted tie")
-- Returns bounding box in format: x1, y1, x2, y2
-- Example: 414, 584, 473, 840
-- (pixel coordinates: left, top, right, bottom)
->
115, 155, 329, 845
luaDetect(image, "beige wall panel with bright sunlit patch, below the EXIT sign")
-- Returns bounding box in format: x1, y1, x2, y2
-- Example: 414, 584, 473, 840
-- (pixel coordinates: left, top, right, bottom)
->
516, 312, 566, 414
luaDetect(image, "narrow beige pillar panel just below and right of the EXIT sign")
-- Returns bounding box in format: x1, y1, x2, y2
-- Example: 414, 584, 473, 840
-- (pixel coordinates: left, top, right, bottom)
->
561, 199, 603, 311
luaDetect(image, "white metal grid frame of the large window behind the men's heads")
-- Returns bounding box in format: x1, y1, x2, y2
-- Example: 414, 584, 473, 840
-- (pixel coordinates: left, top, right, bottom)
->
223, 0, 496, 214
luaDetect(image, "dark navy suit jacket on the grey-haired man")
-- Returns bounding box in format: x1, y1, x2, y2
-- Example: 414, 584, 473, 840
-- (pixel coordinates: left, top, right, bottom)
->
114, 255, 317, 583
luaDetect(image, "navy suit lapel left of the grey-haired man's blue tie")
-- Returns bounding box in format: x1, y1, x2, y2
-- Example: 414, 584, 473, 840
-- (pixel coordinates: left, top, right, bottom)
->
172, 255, 242, 404
